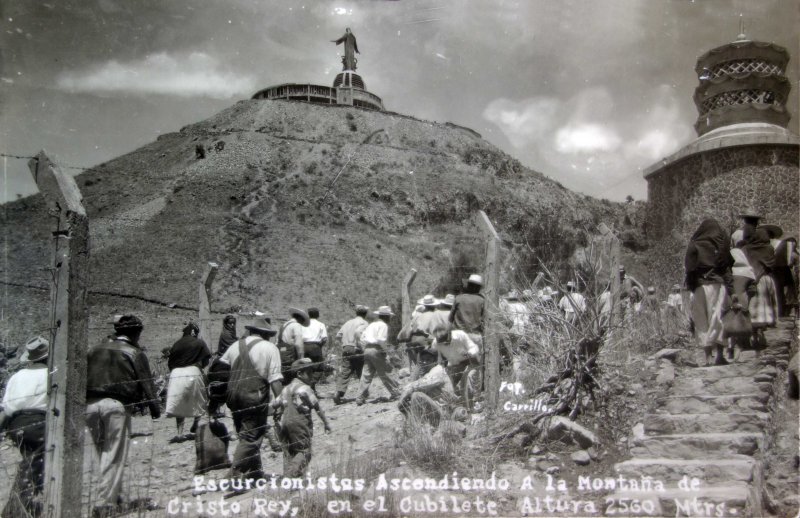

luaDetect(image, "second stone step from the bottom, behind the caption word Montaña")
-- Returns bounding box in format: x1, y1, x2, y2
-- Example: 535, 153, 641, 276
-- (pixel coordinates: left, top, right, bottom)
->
614, 455, 756, 487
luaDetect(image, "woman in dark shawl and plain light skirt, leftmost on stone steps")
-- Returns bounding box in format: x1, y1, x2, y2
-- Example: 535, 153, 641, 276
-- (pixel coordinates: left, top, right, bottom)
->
684, 218, 733, 365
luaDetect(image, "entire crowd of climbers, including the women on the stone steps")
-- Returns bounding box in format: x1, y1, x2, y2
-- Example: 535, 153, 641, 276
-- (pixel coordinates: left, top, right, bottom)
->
0, 213, 798, 517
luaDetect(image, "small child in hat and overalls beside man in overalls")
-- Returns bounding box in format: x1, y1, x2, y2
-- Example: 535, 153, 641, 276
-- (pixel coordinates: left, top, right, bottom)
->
271, 358, 331, 478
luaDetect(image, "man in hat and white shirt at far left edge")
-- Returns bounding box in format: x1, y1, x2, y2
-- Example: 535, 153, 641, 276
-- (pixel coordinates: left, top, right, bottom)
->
0, 336, 50, 516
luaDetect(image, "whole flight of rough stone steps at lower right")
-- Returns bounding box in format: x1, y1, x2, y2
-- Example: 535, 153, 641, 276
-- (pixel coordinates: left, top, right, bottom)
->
607, 322, 793, 516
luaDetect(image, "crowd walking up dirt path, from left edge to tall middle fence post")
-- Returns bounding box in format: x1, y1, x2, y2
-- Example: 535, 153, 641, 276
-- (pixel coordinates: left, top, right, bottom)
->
0, 275, 484, 518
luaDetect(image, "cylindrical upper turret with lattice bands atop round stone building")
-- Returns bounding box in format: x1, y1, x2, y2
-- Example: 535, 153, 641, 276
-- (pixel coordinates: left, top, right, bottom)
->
694, 34, 791, 135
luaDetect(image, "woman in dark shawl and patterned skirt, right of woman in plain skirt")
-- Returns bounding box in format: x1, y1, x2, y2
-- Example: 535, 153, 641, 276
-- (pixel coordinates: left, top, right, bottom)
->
742, 228, 778, 350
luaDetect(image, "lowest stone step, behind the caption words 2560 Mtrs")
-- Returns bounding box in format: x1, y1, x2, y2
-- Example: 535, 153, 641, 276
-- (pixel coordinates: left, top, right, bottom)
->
603, 482, 751, 516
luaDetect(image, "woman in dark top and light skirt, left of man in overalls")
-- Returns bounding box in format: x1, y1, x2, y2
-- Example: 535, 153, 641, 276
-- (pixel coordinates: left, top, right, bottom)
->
167, 322, 211, 442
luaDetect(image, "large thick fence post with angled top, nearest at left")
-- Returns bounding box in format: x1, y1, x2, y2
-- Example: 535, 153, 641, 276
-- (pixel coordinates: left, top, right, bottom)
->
28, 151, 89, 518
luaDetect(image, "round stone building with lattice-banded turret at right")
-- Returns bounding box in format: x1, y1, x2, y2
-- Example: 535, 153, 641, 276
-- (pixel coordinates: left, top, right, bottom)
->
644, 34, 800, 252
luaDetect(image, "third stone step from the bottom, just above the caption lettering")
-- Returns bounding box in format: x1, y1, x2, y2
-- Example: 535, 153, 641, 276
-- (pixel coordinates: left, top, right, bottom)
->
630, 433, 763, 459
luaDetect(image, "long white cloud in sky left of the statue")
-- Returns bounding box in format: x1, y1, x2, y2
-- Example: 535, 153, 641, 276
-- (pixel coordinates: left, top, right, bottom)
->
57, 52, 255, 99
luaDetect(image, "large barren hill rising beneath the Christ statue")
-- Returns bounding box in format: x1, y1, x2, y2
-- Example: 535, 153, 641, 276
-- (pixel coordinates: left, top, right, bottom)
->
1, 100, 625, 350
